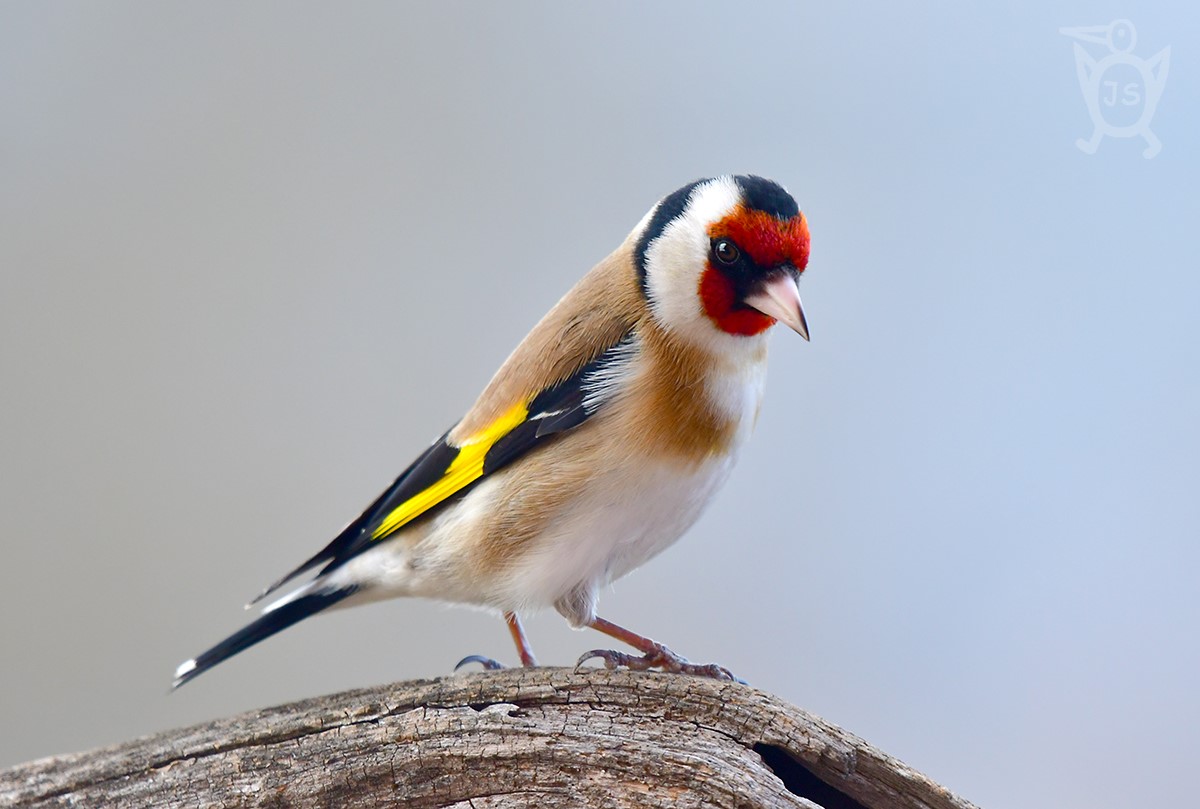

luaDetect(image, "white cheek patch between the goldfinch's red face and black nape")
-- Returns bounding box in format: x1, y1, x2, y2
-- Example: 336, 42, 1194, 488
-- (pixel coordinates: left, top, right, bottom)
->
646, 176, 742, 337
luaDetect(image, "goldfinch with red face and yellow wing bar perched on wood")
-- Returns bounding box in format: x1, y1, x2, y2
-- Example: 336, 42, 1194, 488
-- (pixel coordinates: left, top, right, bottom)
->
173, 174, 809, 688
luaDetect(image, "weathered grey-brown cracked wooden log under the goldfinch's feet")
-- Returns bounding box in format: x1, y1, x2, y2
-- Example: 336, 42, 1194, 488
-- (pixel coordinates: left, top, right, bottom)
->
0, 669, 972, 809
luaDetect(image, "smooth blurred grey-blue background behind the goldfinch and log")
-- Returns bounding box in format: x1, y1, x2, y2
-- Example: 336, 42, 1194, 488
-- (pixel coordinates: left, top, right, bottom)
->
0, 2, 1200, 808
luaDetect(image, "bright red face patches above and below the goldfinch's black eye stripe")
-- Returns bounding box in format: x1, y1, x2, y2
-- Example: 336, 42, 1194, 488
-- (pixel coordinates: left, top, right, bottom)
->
700, 205, 809, 336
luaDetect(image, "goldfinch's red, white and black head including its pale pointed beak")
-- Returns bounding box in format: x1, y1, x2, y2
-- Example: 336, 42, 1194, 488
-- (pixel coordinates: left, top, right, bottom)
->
634, 174, 809, 344
